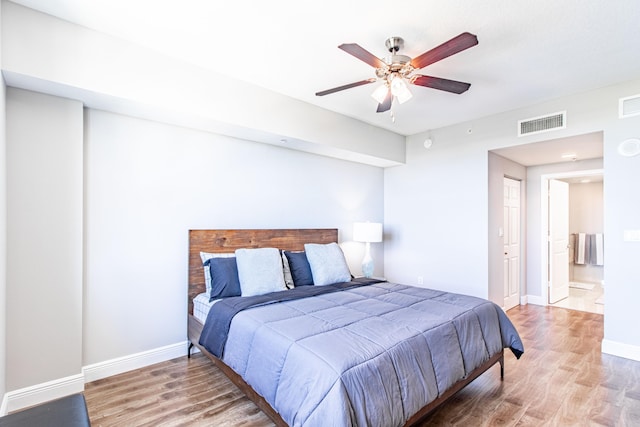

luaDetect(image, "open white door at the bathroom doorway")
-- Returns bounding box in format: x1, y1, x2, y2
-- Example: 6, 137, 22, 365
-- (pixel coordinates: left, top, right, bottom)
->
549, 179, 569, 304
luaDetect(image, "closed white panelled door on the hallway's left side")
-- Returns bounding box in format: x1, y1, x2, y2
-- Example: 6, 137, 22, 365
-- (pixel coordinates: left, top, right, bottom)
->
503, 178, 520, 310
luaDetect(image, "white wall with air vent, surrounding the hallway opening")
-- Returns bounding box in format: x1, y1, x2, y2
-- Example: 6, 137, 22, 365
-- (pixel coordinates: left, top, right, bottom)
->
384, 80, 640, 360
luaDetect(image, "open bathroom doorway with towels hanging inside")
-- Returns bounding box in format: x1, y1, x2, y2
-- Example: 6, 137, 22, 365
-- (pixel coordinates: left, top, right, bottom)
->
541, 170, 604, 314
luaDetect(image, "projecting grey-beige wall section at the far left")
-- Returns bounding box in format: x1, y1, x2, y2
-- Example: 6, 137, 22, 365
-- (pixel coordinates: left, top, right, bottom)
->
6, 88, 83, 391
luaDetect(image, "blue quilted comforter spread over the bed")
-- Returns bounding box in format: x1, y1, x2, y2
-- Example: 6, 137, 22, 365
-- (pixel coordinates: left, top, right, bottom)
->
200, 282, 524, 426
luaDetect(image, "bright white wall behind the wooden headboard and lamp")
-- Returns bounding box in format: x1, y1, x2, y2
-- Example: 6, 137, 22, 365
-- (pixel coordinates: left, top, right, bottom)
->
83, 110, 383, 365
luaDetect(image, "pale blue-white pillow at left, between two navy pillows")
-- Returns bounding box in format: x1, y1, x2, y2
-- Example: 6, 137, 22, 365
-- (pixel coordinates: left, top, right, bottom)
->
236, 248, 287, 297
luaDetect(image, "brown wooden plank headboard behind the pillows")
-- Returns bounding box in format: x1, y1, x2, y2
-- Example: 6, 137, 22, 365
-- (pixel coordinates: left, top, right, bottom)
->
188, 228, 338, 314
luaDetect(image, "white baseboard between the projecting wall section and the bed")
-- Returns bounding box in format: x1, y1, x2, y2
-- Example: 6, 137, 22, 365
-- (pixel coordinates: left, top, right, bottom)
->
82, 341, 187, 383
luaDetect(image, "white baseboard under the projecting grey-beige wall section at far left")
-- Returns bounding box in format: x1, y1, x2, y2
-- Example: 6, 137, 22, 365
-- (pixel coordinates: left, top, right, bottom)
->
3, 374, 84, 414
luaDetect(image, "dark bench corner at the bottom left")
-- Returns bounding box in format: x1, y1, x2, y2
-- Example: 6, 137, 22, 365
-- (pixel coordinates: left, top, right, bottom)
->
0, 394, 91, 427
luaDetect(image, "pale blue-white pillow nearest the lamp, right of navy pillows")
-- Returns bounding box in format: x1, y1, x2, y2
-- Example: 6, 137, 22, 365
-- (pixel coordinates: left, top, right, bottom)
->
304, 243, 351, 286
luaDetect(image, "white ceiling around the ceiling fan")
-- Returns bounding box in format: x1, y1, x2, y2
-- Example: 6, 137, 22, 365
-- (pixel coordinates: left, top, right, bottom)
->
13, 0, 640, 135
